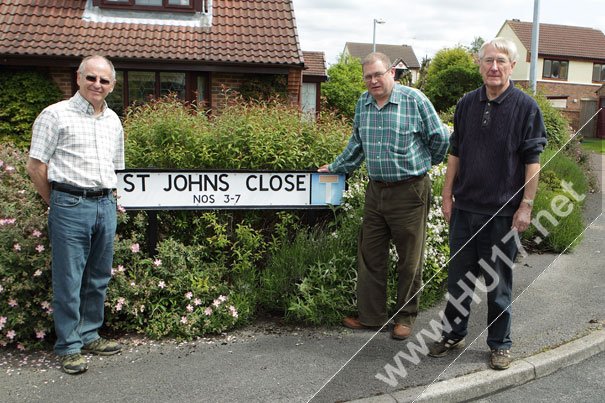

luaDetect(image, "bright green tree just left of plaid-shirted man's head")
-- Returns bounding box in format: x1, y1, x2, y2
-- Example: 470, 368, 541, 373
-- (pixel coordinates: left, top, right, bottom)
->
321, 55, 366, 118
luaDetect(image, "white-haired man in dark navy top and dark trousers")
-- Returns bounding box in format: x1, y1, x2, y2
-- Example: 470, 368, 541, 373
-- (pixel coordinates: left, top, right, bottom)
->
429, 38, 546, 369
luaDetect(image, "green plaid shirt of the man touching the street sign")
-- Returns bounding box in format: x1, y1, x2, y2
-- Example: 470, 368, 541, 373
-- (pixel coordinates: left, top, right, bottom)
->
329, 84, 449, 182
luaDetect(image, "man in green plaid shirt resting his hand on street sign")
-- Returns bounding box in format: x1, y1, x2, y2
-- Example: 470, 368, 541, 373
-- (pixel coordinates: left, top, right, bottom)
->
319, 52, 449, 340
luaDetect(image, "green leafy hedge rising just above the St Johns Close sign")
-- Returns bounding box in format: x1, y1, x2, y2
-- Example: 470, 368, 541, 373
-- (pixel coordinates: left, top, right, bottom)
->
124, 97, 350, 170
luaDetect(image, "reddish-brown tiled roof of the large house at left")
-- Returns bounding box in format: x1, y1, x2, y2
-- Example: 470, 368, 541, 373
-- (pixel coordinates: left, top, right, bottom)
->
0, 0, 304, 66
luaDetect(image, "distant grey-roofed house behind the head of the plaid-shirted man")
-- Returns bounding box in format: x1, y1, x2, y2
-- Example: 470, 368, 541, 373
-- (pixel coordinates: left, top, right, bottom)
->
343, 42, 420, 83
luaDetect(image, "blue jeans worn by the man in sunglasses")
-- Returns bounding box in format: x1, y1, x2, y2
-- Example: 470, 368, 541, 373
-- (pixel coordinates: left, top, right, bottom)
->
48, 190, 117, 355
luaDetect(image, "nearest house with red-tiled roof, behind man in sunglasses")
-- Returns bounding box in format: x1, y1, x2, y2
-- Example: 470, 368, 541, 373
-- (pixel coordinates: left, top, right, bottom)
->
0, 0, 326, 113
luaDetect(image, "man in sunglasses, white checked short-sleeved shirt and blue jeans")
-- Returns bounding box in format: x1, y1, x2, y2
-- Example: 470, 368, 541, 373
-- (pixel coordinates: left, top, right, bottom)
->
27, 56, 124, 374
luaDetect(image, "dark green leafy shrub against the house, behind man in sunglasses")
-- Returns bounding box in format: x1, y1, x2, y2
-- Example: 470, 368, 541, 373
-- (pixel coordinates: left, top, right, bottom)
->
0, 71, 63, 149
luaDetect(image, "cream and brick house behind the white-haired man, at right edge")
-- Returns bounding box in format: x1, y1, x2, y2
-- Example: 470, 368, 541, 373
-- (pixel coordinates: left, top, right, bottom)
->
497, 20, 605, 137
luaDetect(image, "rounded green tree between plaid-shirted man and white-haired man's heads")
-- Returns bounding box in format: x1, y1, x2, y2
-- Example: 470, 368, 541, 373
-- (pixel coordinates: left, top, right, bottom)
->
423, 46, 483, 112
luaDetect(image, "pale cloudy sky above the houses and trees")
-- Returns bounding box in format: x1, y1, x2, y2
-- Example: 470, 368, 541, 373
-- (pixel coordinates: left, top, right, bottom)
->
293, 0, 605, 65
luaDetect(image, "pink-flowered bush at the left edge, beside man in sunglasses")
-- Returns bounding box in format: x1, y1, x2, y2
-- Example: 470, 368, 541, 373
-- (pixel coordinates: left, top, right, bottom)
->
0, 144, 53, 349
